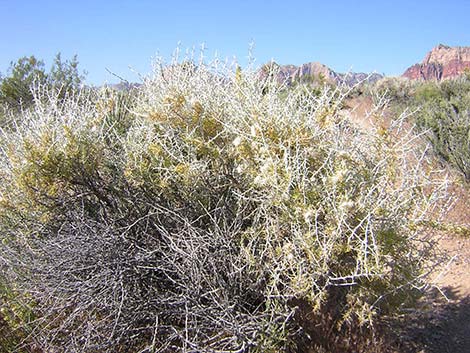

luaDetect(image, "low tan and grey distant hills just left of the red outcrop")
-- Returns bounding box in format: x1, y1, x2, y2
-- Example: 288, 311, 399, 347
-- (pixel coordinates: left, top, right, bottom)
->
261, 62, 383, 86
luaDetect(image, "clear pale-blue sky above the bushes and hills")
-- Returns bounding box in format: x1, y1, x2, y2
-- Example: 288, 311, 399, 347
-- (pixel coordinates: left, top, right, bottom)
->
0, 0, 470, 84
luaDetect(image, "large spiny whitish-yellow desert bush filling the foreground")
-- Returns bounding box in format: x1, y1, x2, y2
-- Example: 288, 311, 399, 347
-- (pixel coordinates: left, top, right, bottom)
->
0, 53, 448, 352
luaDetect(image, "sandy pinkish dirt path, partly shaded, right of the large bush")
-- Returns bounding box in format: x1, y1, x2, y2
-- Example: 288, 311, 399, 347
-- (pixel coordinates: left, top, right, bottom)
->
405, 187, 470, 353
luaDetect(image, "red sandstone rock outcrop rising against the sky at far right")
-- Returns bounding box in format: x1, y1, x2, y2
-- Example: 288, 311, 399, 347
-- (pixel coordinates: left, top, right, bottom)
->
403, 44, 470, 80
